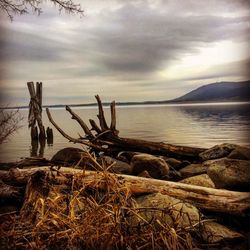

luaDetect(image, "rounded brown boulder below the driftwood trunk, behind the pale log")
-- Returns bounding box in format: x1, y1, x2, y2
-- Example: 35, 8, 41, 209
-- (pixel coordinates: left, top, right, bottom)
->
131, 154, 169, 179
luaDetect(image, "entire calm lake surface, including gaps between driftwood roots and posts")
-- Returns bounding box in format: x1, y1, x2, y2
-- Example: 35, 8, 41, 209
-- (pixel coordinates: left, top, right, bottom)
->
0, 103, 250, 162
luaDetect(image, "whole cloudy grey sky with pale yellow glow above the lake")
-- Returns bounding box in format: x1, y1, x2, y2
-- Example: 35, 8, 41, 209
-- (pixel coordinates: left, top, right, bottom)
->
0, 0, 250, 106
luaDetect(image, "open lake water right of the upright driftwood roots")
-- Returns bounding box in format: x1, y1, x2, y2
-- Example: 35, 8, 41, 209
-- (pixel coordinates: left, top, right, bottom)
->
116, 104, 250, 147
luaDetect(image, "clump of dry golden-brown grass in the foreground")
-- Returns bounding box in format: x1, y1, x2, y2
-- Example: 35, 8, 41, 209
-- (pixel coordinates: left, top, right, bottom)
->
2, 153, 202, 250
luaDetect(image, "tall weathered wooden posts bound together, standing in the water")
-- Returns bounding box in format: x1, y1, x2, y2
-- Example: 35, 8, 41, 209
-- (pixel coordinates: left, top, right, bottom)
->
27, 82, 46, 142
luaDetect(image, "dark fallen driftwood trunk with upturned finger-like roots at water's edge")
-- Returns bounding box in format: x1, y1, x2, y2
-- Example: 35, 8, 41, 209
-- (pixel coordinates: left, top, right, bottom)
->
46, 95, 205, 159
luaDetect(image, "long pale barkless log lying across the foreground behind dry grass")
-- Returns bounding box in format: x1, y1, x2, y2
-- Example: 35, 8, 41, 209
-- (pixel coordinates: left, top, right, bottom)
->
0, 167, 250, 216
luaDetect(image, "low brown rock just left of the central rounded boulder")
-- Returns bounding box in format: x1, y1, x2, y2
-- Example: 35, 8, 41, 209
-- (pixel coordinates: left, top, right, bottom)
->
98, 156, 132, 174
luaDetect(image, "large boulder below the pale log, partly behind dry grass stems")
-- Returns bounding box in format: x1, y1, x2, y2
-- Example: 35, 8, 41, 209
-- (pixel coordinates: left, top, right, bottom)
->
131, 193, 200, 228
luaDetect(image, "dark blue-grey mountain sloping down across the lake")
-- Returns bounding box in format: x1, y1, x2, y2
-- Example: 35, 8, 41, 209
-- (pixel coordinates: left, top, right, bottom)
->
170, 81, 250, 102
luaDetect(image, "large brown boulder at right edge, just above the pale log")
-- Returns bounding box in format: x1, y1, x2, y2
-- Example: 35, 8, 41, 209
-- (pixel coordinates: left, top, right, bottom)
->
204, 158, 250, 191
